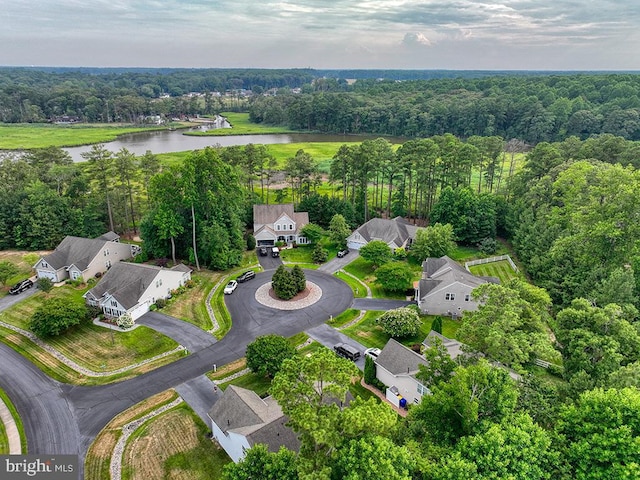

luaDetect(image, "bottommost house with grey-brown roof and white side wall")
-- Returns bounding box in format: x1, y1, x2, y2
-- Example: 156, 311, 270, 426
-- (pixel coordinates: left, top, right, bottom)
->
209, 385, 300, 462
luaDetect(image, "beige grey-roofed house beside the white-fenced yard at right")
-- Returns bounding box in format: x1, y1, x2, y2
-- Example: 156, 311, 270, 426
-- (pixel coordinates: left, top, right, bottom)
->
416, 255, 500, 317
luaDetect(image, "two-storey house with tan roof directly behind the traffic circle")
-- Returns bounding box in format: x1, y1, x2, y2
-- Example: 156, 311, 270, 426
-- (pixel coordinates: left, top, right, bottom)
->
253, 203, 309, 246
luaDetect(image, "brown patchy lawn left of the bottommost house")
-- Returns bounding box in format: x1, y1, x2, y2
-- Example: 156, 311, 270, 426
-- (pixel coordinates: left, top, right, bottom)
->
122, 404, 231, 480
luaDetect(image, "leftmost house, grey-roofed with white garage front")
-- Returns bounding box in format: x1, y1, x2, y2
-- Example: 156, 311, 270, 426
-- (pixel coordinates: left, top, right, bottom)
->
34, 232, 140, 283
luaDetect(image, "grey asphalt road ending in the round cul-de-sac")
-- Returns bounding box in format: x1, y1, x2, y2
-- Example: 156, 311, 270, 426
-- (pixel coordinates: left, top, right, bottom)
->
0, 270, 353, 474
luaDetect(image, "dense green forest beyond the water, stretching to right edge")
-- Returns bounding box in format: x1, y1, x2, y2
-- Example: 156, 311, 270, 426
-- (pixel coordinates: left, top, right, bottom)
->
250, 74, 640, 144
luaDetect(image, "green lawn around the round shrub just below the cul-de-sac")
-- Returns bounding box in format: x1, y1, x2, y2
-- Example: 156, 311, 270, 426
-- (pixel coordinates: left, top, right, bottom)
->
342, 311, 460, 348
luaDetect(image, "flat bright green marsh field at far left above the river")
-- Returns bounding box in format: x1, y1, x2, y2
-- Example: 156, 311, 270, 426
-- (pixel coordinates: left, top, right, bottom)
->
0, 124, 164, 150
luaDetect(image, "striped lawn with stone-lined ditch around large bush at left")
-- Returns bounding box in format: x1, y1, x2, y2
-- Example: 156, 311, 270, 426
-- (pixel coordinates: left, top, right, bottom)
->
0, 286, 185, 385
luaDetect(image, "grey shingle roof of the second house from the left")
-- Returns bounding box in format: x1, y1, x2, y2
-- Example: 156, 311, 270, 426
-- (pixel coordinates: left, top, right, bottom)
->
87, 262, 184, 310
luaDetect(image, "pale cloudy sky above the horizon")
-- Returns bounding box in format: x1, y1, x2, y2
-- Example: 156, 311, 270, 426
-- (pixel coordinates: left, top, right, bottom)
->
0, 0, 640, 70
